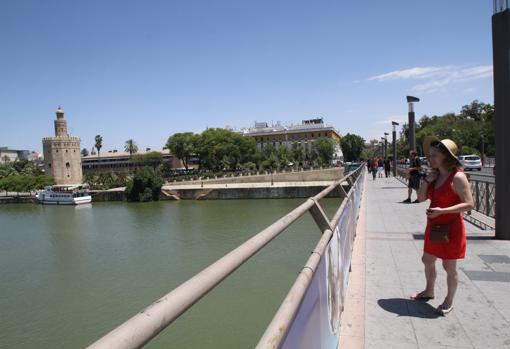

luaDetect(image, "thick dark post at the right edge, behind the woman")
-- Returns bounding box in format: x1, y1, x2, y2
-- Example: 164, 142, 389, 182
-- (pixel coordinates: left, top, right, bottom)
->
492, 0, 510, 240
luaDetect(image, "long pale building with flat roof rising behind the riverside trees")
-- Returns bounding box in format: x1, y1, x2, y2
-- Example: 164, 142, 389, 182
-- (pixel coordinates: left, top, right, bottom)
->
241, 118, 343, 161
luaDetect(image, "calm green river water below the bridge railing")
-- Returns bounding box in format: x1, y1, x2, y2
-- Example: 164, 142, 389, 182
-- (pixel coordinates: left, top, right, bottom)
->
0, 199, 340, 349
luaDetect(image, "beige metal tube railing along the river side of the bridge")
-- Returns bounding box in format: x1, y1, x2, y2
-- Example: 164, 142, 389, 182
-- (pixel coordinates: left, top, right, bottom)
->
88, 166, 366, 349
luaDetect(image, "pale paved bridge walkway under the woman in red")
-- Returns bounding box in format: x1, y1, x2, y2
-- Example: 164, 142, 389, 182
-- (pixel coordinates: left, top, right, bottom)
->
339, 176, 510, 349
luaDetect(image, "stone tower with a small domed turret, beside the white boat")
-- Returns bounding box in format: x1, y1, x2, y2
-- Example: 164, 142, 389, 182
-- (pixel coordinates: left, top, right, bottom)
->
43, 106, 82, 184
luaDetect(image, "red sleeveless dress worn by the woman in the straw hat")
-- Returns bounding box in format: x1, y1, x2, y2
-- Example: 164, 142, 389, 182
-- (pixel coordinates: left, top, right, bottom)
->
423, 170, 466, 259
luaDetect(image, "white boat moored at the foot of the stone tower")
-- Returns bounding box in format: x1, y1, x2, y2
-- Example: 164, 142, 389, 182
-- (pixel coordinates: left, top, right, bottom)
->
37, 184, 92, 205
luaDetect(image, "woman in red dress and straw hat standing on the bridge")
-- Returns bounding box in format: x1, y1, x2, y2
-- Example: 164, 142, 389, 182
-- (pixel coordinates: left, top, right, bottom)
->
412, 136, 474, 315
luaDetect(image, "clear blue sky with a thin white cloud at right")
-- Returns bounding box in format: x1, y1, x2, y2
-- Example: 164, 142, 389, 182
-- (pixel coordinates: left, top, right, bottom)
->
0, 0, 493, 151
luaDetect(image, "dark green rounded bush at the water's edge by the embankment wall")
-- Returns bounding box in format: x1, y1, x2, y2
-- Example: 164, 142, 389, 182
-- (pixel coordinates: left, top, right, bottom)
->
126, 166, 164, 202
